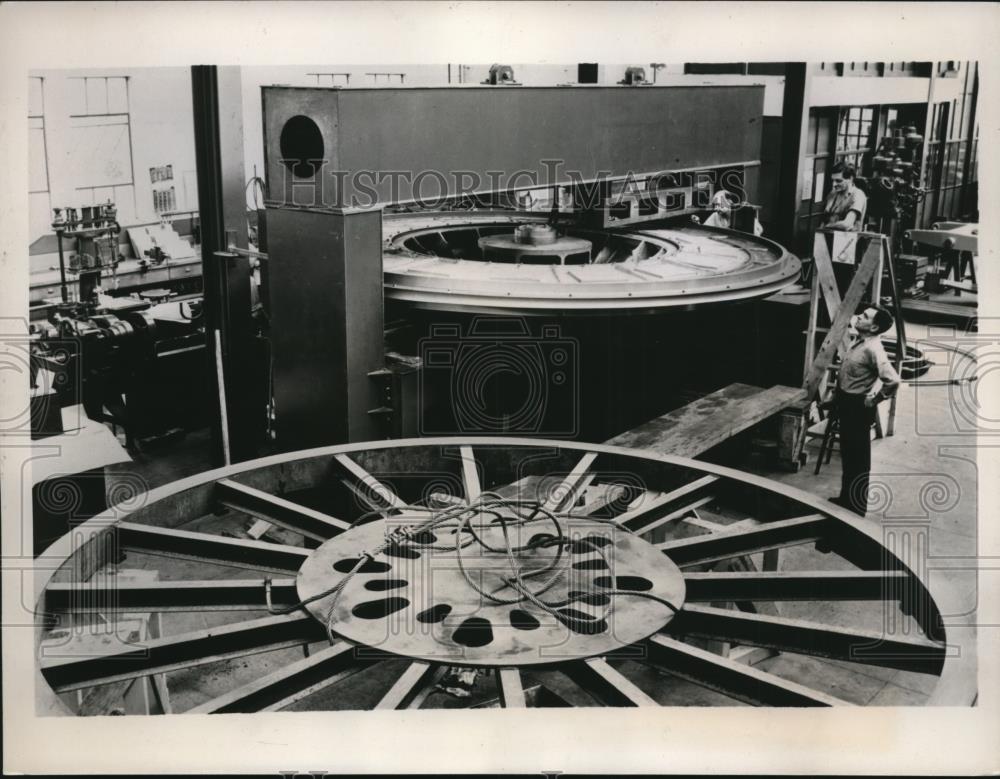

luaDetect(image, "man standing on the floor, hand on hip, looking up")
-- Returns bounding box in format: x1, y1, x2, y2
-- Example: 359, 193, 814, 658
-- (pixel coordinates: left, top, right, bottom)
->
830, 306, 899, 517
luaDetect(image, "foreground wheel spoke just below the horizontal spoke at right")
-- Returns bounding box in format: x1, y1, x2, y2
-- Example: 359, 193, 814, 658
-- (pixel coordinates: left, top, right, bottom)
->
667, 606, 945, 674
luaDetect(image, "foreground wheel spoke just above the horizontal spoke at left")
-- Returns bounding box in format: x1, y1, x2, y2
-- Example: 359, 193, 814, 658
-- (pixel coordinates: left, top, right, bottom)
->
112, 522, 309, 573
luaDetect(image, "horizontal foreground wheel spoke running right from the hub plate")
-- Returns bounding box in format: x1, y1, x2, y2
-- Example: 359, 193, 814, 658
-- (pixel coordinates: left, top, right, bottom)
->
684, 571, 910, 603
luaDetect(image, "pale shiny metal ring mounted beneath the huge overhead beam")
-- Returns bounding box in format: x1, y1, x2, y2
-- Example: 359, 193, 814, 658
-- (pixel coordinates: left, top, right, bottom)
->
383, 211, 801, 314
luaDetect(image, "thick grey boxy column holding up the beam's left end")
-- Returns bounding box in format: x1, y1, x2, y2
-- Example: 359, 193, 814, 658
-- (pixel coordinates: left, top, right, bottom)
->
267, 207, 385, 451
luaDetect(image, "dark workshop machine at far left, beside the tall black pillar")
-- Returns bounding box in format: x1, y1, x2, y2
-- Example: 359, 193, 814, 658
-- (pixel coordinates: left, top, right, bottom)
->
31, 201, 211, 450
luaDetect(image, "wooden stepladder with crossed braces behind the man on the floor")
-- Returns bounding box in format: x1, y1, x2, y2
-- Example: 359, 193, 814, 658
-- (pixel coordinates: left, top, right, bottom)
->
796, 229, 906, 466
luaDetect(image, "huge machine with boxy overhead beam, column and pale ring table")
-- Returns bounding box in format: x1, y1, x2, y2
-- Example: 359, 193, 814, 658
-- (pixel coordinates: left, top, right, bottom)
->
263, 86, 799, 450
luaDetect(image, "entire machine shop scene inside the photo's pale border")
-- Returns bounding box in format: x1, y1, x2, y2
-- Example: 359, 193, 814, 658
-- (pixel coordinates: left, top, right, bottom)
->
28, 61, 988, 716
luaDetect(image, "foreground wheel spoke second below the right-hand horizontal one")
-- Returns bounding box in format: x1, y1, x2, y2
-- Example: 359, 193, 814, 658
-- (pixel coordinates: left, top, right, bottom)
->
644, 636, 851, 706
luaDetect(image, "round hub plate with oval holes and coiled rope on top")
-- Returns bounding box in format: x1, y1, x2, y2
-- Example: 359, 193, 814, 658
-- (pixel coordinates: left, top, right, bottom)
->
298, 513, 685, 666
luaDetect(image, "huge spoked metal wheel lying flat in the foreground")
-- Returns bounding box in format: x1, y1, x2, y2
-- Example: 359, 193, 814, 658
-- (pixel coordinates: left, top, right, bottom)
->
37, 438, 975, 714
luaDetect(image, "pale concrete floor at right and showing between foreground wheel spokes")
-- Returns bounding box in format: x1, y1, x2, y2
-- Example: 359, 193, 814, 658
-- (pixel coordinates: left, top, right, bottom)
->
86, 312, 985, 711
